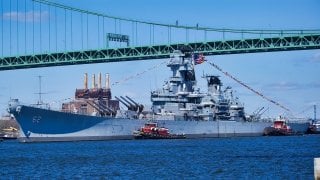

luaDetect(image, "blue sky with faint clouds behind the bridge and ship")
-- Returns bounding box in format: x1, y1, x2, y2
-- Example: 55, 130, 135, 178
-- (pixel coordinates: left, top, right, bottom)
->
0, 0, 320, 117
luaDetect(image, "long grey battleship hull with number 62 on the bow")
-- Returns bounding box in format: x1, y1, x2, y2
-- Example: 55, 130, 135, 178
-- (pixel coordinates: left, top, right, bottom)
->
10, 105, 308, 142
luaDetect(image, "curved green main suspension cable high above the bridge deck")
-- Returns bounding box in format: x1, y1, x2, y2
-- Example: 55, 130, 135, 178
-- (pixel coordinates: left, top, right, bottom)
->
32, 0, 320, 36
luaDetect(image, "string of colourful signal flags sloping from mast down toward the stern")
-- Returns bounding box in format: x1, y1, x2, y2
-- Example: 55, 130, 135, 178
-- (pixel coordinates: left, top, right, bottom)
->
206, 61, 291, 113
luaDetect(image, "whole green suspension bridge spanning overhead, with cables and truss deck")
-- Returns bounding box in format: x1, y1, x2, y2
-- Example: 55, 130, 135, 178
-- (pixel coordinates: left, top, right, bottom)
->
0, 0, 320, 71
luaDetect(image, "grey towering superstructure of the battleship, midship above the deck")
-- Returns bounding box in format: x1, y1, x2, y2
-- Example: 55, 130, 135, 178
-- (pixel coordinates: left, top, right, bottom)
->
151, 52, 245, 121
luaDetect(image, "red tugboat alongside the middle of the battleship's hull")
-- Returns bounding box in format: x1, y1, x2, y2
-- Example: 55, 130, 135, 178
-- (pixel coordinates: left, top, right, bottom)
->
133, 123, 186, 139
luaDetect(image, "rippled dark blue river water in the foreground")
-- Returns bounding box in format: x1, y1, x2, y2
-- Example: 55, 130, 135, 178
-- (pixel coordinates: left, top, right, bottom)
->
0, 135, 320, 179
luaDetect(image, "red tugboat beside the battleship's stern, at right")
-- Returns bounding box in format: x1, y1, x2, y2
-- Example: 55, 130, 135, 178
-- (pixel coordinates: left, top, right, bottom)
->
263, 116, 292, 136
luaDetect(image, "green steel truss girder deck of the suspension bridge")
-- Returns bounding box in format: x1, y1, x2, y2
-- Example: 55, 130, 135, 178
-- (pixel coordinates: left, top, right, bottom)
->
0, 34, 320, 71
